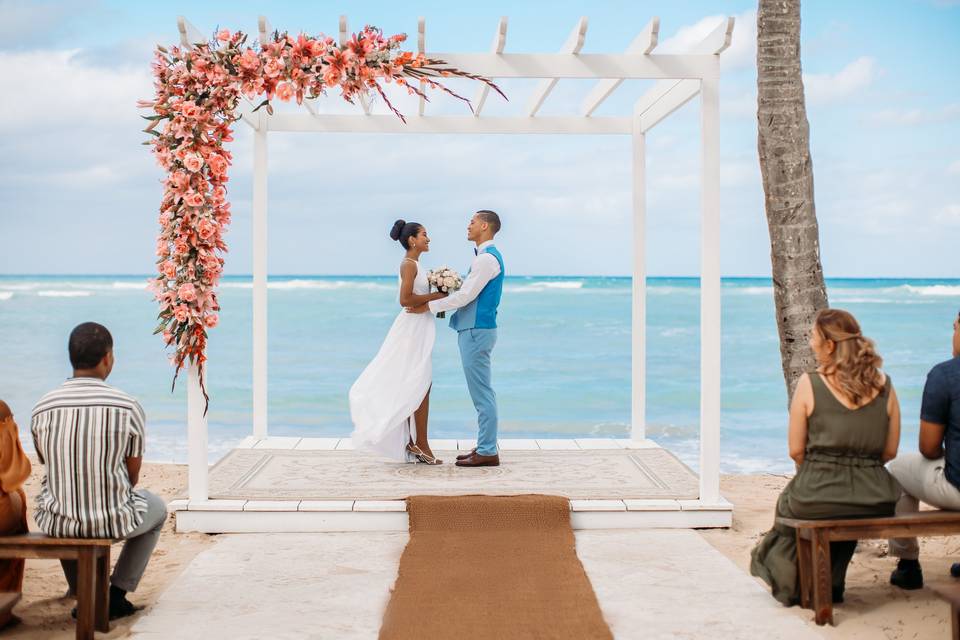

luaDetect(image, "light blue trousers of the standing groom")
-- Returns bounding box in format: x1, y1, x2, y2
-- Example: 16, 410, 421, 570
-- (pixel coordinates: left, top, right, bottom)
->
457, 329, 497, 456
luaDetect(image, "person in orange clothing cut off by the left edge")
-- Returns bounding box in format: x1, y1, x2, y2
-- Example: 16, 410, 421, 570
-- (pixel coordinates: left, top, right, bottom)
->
0, 400, 30, 629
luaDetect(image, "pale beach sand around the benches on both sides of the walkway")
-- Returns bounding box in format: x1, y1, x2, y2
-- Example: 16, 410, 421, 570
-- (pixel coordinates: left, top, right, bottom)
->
4, 461, 960, 640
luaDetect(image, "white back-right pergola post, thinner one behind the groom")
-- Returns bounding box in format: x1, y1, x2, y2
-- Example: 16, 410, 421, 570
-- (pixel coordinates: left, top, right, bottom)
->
630, 112, 647, 440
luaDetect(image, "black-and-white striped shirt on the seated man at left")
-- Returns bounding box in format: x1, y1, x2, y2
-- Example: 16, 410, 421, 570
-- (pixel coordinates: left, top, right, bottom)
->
30, 378, 147, 538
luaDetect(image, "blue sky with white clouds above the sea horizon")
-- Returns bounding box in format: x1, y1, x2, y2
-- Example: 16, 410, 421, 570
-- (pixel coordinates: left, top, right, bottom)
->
0, 0, 960, 277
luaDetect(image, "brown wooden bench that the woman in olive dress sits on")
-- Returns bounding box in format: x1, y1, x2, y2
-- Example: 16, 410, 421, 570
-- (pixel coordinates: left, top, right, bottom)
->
777, 511, 960, 625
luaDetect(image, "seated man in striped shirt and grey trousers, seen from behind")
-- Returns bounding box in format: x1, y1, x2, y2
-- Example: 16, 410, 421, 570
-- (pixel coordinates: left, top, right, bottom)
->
30, 322, 167, 619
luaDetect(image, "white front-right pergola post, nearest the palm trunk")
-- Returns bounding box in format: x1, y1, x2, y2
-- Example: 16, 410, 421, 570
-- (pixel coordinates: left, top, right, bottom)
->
700, 63, 721, 504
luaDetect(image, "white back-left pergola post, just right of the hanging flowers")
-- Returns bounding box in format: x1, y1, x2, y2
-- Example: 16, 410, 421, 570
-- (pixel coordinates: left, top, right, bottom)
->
253, 111, 267, 438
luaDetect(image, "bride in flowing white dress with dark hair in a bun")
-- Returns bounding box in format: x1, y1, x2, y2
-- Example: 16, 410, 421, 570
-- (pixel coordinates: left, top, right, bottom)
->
350, 220, 447, 464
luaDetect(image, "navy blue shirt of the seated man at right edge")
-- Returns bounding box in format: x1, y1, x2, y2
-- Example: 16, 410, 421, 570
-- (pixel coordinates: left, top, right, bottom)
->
920, 357, 960, 489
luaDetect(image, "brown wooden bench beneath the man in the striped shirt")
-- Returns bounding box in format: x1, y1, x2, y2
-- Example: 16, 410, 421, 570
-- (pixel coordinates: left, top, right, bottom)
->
0, 533, 113, 640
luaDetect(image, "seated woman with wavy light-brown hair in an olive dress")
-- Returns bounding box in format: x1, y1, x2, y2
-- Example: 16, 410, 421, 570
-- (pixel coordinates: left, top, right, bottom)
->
750, 309, 900, 606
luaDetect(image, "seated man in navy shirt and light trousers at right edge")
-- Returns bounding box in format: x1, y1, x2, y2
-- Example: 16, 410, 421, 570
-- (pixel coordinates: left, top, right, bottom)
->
888, 315, 960, 589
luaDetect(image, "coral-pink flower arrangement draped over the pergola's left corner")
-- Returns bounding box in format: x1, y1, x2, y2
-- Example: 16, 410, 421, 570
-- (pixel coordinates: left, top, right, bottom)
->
138, 26, 506, 410
